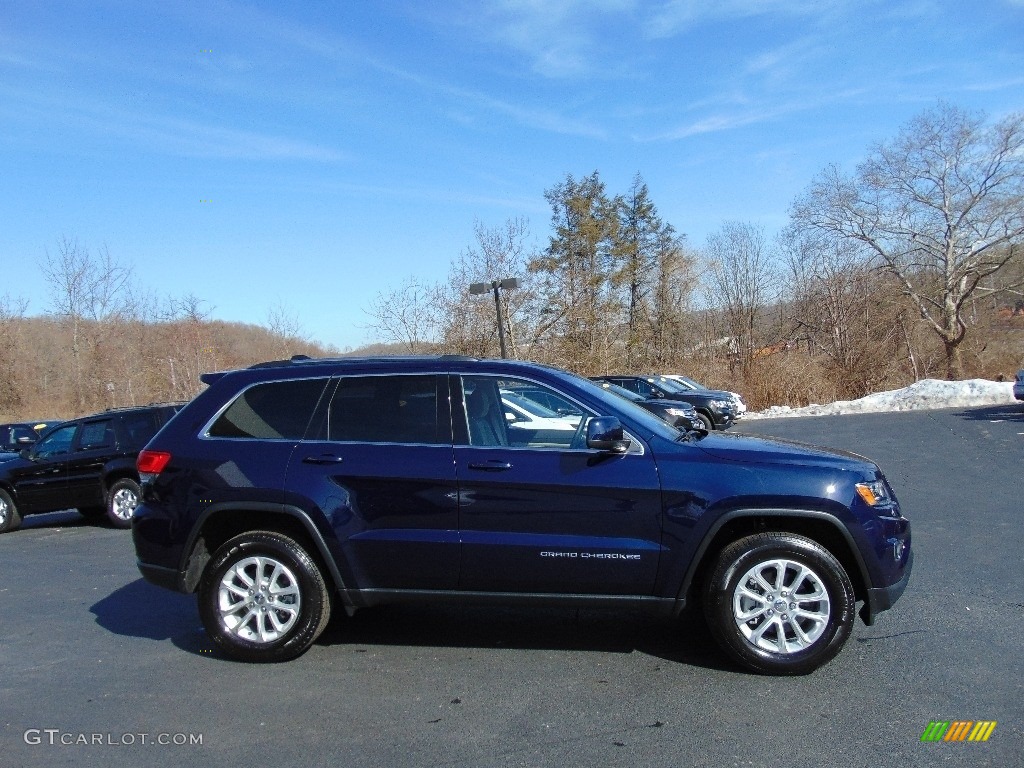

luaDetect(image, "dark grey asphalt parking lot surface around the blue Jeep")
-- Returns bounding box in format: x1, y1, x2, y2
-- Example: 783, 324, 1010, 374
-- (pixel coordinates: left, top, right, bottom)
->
0, 406, 1024, 768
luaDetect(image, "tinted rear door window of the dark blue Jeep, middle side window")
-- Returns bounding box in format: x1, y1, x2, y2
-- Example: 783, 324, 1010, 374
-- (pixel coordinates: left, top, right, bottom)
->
328, 375, 440, 445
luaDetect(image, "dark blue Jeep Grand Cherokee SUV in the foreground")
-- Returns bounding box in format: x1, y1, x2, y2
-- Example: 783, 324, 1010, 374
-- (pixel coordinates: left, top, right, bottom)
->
132, 356, 912, 674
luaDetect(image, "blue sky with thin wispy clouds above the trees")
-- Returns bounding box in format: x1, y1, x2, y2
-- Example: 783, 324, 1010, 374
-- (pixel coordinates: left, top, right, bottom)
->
0, 0, 1024, 347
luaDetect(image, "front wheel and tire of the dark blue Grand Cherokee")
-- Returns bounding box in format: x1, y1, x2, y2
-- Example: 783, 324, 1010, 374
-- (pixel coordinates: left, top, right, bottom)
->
703, 531, 856, 675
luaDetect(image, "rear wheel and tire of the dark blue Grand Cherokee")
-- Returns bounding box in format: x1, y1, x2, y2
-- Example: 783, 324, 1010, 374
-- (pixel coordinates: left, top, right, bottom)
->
199, 530, 331, 663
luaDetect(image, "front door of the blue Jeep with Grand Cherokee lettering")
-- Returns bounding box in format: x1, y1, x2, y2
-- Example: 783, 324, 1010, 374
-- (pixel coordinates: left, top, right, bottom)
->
454, 376, 662, 595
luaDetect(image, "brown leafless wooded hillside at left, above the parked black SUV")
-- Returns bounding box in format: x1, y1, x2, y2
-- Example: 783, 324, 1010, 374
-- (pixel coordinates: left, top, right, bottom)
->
0, 280, 336, 421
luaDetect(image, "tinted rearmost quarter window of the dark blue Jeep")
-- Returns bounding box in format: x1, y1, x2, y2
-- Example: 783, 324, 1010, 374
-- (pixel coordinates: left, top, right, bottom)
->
208, 379, 328, 440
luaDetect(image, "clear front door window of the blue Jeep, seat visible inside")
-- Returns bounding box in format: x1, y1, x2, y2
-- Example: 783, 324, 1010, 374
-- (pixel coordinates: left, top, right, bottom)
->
463, 376, 586, 450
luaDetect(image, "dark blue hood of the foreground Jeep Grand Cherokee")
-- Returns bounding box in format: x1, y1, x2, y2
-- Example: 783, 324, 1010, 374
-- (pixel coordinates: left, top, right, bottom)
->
696, 432, 879, 477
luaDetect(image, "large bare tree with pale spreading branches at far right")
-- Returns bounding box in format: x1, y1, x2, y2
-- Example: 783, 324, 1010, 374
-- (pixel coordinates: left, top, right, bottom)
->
792, 103, 1024, 379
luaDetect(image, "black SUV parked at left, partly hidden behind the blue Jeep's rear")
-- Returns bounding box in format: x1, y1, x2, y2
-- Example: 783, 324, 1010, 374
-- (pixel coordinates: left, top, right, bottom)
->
0, 403, 181, 534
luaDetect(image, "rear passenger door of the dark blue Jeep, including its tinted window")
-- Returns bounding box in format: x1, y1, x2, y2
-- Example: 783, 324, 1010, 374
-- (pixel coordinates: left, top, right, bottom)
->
287, 373, 459, 590
